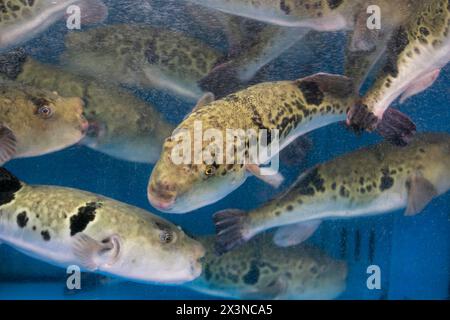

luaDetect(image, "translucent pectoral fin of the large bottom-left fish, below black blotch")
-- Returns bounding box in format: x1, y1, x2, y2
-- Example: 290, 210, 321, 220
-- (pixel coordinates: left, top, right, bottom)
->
72, 232, 121, 271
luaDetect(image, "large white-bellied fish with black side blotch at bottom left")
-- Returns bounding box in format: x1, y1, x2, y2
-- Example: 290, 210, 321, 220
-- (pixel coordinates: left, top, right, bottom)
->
0, 168, 204, 283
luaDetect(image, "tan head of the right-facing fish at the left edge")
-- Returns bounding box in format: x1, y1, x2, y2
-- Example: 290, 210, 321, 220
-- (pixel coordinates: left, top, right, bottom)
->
17, 90, 89, 156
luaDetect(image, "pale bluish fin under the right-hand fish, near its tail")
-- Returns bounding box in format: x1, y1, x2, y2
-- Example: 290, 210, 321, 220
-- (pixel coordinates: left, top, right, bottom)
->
273, 220, 322, 248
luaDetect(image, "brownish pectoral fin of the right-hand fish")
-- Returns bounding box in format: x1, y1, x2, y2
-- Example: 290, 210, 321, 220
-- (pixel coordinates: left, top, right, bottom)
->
405, 175, 438, 216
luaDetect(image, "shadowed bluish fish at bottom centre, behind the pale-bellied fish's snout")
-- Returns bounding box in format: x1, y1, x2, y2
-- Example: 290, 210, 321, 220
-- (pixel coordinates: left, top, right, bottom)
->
184, 237, 347, 300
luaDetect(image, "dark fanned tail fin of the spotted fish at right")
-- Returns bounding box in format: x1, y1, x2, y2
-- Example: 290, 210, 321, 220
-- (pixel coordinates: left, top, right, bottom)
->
213, 209, 248, 255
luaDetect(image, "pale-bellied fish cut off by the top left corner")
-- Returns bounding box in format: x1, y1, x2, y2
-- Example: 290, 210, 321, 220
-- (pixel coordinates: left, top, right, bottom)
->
0, 0, 107, 51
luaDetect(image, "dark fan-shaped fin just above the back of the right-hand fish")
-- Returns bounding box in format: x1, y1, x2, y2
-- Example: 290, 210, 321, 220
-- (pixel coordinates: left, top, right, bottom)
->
377, 108, 417, 147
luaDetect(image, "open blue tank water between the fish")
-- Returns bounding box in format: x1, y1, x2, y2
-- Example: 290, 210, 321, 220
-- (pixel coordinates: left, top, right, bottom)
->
0, 1, 450, 299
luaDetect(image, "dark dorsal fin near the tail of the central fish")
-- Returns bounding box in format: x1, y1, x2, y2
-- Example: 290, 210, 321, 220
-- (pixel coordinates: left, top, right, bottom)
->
296, 72, 355, 97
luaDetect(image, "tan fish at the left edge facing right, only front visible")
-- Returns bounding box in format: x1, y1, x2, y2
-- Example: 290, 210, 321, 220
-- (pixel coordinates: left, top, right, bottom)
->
0, 81, 88, 165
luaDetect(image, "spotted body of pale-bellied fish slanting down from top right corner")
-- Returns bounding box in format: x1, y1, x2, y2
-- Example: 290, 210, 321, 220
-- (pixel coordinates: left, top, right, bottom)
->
352, 0, 450, 122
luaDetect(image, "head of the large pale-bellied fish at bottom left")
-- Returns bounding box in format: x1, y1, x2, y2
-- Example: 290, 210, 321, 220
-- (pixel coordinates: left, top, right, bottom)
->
126, 217, 205, 284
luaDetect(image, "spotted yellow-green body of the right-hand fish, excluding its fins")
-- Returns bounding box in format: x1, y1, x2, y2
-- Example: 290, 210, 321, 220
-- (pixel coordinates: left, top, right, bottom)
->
242, 133, 450, 239
